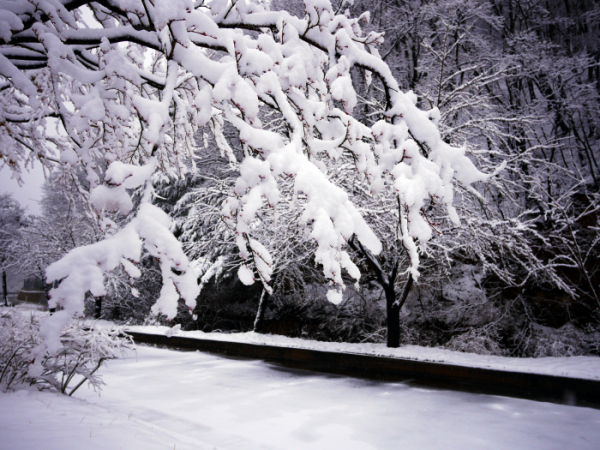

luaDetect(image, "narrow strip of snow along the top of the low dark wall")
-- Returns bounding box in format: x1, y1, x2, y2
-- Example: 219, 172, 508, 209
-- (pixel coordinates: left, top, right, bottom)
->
128, 326, 600, 380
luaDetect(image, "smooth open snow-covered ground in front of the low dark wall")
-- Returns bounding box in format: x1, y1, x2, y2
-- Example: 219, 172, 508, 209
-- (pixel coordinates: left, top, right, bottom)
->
0, 347, 600, 450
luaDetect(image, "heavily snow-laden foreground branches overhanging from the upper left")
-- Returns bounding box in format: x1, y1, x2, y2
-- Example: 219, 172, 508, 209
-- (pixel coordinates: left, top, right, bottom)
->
0, 0, 486, 348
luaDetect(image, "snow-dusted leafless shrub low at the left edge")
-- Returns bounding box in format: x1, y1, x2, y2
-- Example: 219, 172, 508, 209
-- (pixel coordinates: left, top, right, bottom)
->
0, 310, 133, 395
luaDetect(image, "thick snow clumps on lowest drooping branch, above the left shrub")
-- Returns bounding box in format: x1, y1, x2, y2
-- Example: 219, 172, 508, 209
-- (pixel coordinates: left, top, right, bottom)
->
37, 159, 200, 356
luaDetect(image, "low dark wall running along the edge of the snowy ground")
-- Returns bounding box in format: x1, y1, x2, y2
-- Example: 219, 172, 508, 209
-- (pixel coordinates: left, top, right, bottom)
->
128, 332, 600, 408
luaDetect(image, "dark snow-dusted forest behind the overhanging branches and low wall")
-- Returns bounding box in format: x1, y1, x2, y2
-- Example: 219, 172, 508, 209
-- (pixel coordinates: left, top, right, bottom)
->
0, 0, 600, 356
